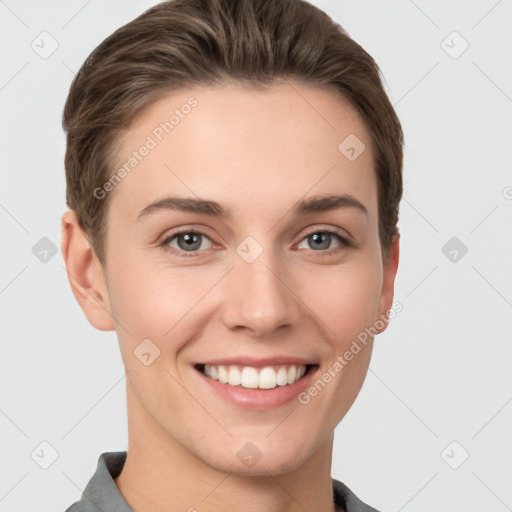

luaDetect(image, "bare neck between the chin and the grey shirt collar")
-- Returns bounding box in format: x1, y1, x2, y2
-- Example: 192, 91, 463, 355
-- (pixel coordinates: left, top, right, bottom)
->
115, 382, 336, 512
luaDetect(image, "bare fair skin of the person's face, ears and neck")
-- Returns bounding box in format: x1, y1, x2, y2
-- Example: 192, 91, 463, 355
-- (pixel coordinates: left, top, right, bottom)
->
62, 83, 398, 512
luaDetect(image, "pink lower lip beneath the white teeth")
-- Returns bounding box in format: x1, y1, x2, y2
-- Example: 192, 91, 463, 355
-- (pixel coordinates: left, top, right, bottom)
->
194, 366, 318, 410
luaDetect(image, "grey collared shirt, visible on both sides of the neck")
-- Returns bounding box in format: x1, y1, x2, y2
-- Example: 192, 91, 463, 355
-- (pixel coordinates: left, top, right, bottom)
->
66, 452, 379, 512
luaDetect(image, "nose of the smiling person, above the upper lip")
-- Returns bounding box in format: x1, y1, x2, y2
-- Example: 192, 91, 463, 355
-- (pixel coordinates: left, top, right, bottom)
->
223, 250, 301, 337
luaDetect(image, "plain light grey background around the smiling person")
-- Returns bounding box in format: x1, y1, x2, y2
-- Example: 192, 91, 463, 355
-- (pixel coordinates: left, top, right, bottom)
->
0, 0, 512, 512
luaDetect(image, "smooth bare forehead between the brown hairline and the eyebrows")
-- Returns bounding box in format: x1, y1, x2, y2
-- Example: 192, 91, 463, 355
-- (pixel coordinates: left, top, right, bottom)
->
112, 82, 377, 222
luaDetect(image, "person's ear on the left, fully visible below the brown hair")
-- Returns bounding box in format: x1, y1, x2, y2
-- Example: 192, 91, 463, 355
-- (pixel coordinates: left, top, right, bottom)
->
61, 210, 115, 331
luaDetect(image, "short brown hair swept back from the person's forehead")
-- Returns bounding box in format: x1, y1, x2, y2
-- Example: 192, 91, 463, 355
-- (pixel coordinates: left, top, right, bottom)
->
62, 0, 403, 264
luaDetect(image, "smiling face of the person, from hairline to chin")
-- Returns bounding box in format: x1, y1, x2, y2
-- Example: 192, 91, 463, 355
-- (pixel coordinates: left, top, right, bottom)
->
83, 81, 396, 475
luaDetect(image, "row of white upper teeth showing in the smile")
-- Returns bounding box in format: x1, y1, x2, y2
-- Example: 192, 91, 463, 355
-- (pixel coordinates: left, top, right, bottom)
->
204, 364, 306, 389
